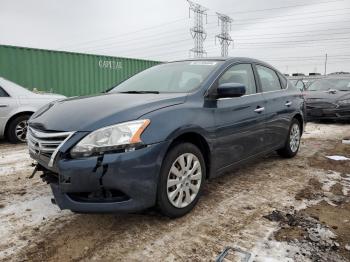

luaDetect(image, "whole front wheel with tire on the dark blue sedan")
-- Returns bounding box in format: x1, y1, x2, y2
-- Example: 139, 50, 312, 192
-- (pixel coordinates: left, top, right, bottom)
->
157, 143, 206, 218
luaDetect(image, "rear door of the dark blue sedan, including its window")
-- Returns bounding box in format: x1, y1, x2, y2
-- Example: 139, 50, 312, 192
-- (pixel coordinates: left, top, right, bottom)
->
255, 64, 294, 149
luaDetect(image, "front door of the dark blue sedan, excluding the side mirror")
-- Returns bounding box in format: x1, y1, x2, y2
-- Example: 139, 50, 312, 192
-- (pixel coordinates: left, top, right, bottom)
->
214, 63, 265, 169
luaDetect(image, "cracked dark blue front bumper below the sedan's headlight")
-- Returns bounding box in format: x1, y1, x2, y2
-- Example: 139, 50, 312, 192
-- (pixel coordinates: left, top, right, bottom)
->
32, 142, 168, 213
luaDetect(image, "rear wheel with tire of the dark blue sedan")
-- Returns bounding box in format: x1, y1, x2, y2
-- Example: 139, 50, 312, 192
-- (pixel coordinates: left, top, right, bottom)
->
277, 118, 301, 158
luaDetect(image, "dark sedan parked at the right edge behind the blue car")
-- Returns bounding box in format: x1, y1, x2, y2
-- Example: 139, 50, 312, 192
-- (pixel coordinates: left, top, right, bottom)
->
305, 77, 350, 120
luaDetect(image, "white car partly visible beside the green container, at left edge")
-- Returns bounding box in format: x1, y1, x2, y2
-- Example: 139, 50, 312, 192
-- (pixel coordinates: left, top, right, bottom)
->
0, 77, 66, 143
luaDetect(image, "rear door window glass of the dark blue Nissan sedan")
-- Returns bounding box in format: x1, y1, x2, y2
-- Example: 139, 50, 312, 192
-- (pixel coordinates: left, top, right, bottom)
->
256, 65, 281, 92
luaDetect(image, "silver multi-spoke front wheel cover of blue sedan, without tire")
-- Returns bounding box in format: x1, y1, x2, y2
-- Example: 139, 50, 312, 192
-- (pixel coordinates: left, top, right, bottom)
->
167, 153, 202, 208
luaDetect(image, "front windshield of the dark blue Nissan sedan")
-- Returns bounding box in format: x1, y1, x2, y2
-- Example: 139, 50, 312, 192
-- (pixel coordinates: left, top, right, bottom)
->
109, 61, 223, 93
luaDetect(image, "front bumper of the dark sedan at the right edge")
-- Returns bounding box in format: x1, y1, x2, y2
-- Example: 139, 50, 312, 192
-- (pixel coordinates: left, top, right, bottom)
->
306, 106, 350, 120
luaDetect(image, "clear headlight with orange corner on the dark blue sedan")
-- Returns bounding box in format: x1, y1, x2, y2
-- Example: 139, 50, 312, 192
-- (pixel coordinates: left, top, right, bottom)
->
70, 119, 150, 158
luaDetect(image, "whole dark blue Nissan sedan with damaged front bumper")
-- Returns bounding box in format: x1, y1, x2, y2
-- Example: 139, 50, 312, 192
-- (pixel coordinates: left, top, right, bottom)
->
28, 58, 305, 217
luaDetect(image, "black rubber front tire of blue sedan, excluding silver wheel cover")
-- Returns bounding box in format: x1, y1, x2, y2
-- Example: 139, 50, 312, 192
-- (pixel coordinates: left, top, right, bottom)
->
157, 143, 206, 218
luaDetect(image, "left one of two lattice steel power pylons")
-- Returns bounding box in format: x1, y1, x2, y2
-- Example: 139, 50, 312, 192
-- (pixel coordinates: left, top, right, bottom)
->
187, 0, 208, 57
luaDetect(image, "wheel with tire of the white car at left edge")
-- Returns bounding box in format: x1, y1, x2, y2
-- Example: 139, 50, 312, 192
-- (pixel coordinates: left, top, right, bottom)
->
6, 114, 30, 144
